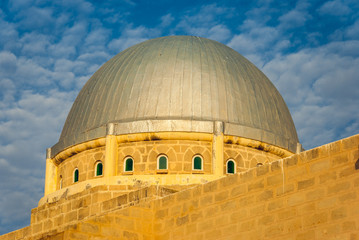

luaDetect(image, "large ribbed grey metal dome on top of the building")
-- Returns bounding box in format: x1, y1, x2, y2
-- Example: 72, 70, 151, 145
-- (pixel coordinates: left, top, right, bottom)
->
52, 36, 298, 154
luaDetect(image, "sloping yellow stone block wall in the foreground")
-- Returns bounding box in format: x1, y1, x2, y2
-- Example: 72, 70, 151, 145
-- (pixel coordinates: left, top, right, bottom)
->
0, 135, 359, 240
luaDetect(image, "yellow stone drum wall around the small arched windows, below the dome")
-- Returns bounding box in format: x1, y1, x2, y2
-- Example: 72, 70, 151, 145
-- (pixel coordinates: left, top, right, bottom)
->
56, 137, 281, 190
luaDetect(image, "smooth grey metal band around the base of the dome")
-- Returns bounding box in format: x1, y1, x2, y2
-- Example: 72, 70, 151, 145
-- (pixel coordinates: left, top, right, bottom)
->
51, 119, 299, 158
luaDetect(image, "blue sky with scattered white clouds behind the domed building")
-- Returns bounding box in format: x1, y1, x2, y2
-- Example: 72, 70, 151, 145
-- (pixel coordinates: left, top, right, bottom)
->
0, 0, 359, 234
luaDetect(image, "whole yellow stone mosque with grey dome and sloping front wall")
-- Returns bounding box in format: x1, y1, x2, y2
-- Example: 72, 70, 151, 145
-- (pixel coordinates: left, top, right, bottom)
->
0, 36, 359, 240
